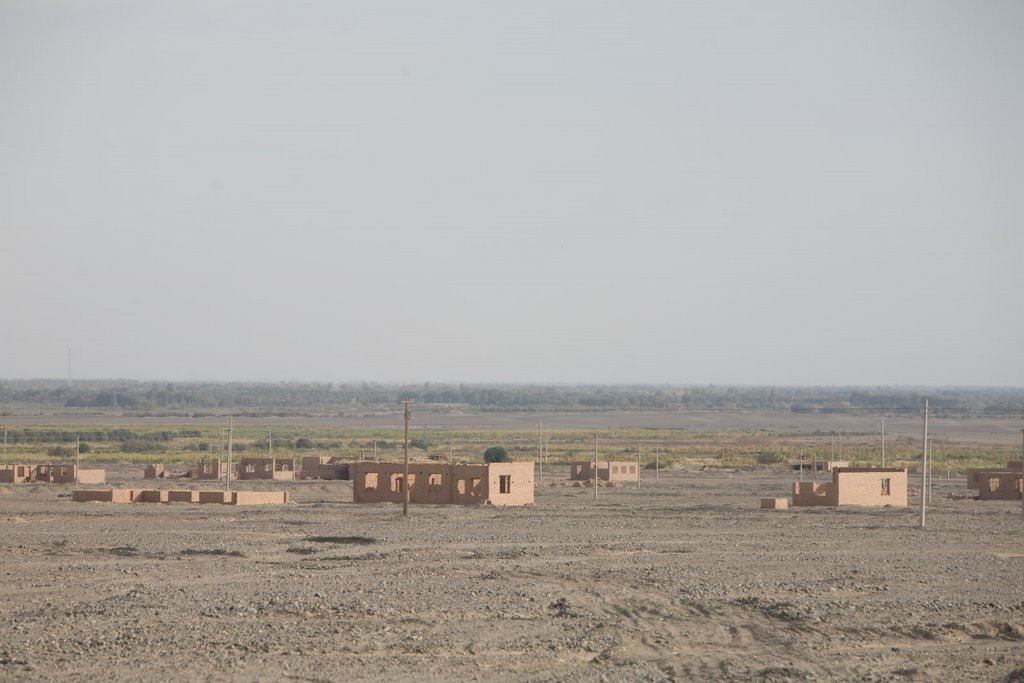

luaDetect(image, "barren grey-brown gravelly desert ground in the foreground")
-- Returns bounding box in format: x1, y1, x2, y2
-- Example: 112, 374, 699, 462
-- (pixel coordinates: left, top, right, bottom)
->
0, 465, 1024, 681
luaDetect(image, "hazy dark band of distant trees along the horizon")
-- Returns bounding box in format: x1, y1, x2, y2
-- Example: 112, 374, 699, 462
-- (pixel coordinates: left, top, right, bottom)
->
0, 380, 1024, 417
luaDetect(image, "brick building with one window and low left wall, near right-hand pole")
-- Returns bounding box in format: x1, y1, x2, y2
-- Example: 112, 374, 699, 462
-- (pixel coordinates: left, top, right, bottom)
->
793, 467, 907, 507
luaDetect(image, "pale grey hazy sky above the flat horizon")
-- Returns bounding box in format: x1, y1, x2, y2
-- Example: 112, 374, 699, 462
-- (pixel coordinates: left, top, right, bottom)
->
0, 0, 1024, 386
